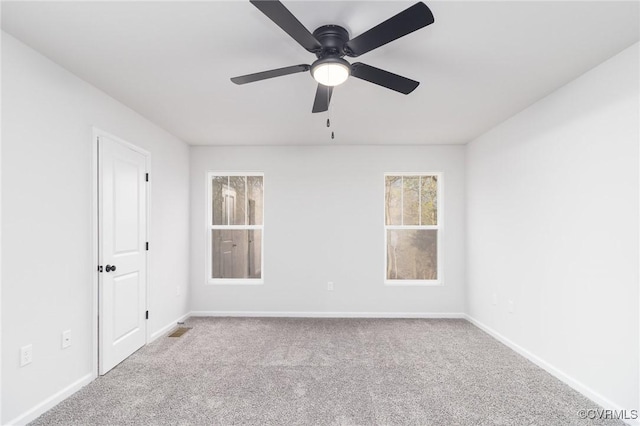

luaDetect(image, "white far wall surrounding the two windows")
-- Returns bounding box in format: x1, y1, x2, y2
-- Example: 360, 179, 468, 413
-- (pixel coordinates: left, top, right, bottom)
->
191, 142, 465, 314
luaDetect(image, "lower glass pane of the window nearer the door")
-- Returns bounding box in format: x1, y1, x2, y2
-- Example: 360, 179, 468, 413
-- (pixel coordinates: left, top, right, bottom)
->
211, 229, 262, 278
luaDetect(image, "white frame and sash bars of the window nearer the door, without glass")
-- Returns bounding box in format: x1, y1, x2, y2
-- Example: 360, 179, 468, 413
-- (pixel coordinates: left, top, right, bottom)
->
205, 171, 265, 286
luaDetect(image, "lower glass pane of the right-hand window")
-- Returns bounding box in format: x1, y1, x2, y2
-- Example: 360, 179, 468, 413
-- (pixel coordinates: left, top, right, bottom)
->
387, 229, 438, 280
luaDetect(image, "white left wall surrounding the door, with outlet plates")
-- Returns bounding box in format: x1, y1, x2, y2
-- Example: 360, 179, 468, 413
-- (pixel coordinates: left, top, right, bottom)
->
2, 33, 189, 423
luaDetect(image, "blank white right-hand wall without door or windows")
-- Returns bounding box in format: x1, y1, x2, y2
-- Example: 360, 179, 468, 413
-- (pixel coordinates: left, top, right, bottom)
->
467, 44, 640, 410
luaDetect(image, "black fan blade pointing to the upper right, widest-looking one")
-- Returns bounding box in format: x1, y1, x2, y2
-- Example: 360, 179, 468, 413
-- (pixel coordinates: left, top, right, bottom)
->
345, 2, 434, 57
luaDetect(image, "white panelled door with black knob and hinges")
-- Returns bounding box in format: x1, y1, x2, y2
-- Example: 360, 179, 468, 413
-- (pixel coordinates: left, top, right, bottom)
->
98, 136, 147, 374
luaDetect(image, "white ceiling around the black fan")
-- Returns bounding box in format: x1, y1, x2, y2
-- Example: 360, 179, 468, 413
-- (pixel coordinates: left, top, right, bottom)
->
2, 0, 640, 145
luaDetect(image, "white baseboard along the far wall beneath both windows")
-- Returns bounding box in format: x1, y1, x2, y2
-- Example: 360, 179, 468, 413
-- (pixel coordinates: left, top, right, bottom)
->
191, 311, 465, 318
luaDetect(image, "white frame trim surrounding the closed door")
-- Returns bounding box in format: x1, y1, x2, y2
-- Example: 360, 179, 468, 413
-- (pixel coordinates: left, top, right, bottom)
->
91, 127, 151, 378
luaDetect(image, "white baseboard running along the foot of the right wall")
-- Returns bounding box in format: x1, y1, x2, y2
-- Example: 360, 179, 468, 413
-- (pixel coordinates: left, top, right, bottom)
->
464, 314, 640, 426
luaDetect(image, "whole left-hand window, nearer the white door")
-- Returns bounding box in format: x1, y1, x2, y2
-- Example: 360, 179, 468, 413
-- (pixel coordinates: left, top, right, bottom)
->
207, 173, 264, 284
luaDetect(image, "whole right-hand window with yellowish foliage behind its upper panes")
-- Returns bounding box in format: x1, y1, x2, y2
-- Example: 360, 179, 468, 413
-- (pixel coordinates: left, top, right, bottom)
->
384, 173, 442, 285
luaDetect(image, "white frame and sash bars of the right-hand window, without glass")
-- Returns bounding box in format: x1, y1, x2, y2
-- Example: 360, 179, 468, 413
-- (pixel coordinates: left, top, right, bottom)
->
382, 172, 444, 287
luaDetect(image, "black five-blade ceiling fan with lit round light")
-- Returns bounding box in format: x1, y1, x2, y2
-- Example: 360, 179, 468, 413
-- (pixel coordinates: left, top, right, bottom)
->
231, 0, 434, 112
